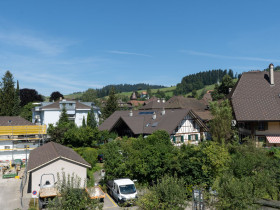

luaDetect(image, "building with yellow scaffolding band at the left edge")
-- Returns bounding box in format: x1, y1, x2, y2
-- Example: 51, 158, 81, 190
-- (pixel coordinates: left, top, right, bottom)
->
0, 116, 46, 162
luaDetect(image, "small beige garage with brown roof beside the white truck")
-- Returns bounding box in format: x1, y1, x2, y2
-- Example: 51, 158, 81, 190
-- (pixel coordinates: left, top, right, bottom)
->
27, 142, 91, 193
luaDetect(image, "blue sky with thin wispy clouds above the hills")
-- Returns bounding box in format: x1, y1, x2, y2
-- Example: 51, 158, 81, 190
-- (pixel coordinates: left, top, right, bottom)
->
0, 0, 280, 95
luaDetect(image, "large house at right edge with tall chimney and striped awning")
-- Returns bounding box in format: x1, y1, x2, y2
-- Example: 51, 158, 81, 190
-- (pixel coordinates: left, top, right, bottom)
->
229, 64, 280, 146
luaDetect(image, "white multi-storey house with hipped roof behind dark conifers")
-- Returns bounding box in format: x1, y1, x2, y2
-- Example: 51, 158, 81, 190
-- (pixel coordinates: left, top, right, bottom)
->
32, 99, 101, 126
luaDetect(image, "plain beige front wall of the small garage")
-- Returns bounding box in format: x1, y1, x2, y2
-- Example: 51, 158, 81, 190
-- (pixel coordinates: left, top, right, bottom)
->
31, 159, 87, 192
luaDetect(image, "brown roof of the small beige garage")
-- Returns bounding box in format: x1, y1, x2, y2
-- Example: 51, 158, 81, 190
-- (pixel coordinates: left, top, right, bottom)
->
27, 142, 91, 172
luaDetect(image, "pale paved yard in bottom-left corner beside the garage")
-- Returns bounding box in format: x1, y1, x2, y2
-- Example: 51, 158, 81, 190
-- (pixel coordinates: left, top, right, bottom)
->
0, 174, 21, 210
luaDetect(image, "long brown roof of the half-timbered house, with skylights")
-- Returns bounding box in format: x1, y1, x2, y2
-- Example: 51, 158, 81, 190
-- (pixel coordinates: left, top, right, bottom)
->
99, 109, 207, 135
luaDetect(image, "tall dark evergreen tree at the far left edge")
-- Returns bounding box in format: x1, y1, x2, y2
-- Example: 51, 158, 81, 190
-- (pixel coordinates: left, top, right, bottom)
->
0, 71, 16, 116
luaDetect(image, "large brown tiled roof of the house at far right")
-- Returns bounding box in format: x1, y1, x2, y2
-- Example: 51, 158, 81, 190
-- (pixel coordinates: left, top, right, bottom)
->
229, 71, 280, 121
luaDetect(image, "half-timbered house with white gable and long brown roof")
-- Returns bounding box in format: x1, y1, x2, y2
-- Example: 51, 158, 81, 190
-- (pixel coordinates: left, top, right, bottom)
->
99, 108, 210, 146
